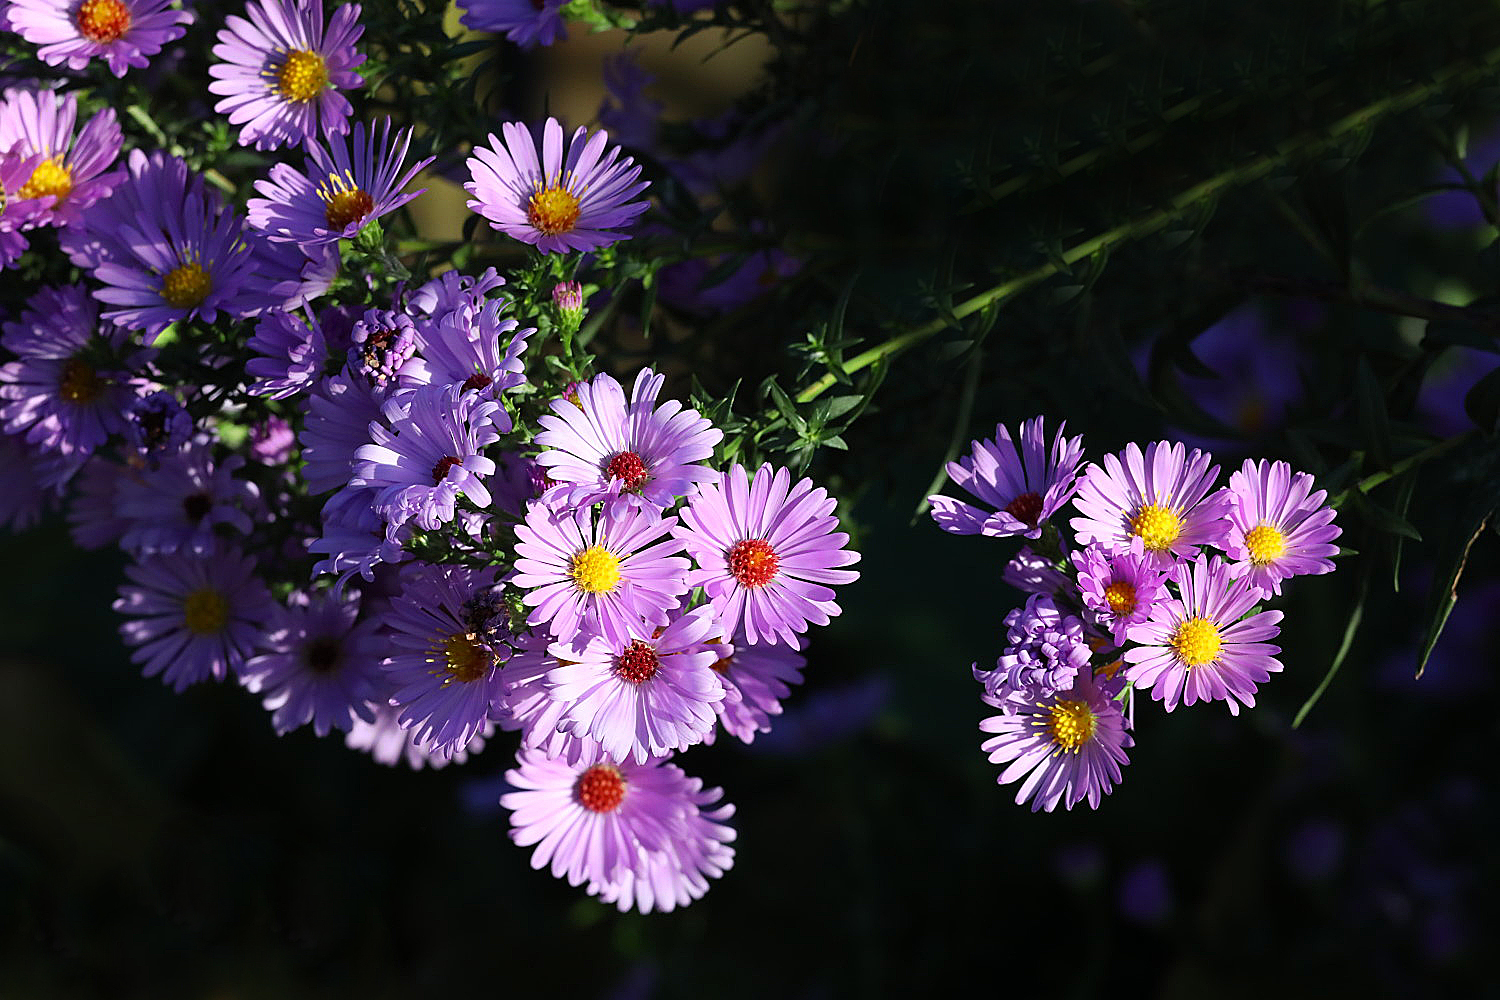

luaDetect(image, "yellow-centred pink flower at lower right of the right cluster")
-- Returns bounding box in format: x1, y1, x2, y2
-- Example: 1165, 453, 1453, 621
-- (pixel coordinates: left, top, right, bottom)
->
1125, 556, 1281, 715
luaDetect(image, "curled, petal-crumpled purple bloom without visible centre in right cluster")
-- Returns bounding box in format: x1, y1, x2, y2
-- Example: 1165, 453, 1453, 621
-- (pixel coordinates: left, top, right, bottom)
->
974, 594, 1094, 703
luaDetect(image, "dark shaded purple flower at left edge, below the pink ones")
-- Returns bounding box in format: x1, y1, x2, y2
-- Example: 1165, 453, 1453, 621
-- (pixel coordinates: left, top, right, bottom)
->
0, 286, 146, 454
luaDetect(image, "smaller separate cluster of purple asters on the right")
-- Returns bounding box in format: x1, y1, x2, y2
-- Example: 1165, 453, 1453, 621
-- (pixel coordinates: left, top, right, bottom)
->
929, 417, 1340, 811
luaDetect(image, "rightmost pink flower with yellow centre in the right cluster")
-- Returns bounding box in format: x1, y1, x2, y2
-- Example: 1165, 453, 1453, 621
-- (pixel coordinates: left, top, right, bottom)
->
1224, 459, 1343, 597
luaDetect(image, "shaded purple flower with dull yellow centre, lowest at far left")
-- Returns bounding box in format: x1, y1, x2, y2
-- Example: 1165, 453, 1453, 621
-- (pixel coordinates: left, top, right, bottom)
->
114, 546, 275, 691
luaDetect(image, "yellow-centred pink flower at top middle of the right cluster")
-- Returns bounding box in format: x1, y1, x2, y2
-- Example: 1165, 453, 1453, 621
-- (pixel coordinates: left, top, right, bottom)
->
1071, 441, 1229, 565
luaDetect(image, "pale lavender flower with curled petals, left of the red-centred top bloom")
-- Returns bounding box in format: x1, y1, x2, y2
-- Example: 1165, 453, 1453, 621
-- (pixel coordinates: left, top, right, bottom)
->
350, 385, 510, 531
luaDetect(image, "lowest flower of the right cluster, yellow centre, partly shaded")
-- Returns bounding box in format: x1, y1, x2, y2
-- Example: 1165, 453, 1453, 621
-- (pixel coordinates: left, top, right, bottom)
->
980, 670, 1136, 813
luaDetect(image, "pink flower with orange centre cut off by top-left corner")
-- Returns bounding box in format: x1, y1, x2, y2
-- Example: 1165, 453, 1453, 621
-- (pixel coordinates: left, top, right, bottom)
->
6, 0, 192, 76
